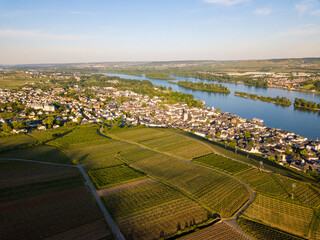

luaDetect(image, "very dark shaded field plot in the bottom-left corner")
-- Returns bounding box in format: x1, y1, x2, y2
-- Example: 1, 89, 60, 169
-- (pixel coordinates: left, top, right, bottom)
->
0, 187, 107, 239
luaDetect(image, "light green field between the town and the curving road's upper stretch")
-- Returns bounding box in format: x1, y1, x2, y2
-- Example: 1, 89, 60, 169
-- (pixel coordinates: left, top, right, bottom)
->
104, 127, 212, 160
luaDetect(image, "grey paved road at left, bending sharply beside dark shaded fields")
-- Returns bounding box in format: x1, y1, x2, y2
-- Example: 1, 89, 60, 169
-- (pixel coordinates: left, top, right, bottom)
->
0, 158, 125, 240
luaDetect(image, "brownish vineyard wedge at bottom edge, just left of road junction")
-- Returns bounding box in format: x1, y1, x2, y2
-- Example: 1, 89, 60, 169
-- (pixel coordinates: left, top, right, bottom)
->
179, 222, 247, 240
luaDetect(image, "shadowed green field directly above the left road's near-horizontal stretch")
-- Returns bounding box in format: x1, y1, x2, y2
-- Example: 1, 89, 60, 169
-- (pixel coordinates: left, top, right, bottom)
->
0, 145, 72, 164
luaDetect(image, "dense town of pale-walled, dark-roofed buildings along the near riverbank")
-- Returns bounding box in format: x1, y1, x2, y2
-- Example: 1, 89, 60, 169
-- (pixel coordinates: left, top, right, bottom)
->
0, 86, 320, 173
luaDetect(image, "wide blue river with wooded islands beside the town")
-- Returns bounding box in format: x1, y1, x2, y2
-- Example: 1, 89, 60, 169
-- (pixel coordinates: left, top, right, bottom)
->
106, 73, 320, 140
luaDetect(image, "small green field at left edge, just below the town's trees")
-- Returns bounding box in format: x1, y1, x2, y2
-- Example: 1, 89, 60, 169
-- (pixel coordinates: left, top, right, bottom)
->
0, 134, 36, 152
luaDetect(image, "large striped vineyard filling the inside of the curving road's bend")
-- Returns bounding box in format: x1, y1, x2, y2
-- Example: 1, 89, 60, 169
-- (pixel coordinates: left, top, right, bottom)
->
132, 154, 250, 217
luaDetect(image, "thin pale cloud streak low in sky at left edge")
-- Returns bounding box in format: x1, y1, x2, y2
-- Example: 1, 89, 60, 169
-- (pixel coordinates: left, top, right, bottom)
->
0, 29, 89, 41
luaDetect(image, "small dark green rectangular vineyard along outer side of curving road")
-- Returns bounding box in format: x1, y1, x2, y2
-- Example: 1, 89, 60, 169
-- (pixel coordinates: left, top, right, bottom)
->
193, 154, 251, 175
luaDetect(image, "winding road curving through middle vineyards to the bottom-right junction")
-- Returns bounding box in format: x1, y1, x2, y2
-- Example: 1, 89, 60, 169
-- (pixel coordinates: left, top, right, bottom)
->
98, 129, 254, 240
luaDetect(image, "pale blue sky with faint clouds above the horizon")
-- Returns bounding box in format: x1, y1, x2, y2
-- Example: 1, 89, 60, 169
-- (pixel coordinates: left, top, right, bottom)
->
0, 0, 320, 64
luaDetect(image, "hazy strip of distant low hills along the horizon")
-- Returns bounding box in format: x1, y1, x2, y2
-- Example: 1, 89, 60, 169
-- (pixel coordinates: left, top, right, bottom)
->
2, 58, 320, 72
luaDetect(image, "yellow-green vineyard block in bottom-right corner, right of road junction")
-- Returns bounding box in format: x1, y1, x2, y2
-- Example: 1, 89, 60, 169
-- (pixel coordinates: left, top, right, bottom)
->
244, 194, 313, 237
